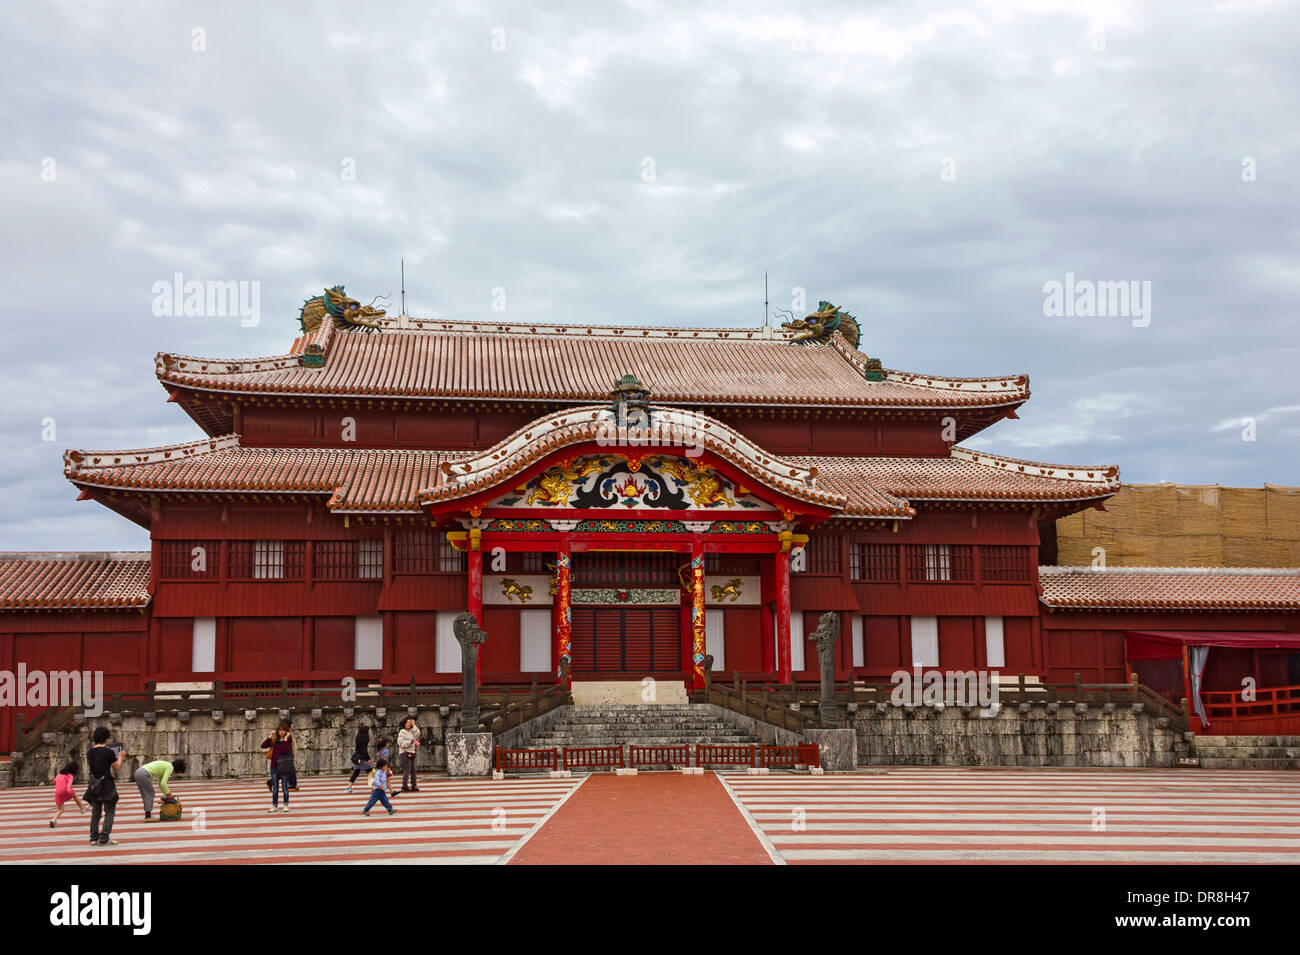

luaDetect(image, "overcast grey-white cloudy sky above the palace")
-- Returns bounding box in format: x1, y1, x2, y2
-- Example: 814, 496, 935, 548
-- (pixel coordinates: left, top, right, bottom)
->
0, 0, 1300, 550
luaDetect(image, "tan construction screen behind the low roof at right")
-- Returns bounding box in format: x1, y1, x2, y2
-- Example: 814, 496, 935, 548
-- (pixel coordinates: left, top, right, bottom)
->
1057, 483, 1300, 568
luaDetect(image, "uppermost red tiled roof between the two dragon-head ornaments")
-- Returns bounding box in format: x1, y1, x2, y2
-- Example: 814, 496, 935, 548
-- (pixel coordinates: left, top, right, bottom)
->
156, 320, 1030, 408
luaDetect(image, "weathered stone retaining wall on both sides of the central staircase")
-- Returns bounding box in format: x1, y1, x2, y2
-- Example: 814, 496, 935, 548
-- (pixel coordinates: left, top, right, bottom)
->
0, 706, 1188, 789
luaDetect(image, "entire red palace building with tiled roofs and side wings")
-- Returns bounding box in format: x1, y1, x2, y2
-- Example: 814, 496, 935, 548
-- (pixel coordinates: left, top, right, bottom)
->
0, 287, 1300, 750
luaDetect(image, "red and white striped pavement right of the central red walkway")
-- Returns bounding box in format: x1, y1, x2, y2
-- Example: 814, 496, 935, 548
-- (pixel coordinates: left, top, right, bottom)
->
723, 768, 1300, 865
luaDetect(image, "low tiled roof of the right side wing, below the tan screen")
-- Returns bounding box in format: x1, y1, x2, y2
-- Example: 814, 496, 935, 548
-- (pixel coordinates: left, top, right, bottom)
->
1039, 567, 1300, 611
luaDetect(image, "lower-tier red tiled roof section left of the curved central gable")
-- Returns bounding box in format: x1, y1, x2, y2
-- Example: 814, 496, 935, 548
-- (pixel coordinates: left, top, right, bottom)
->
64, 434, 465, 512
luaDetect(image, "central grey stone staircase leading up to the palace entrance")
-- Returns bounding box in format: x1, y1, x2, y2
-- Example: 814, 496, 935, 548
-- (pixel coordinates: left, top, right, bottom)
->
525, 703, 762, 750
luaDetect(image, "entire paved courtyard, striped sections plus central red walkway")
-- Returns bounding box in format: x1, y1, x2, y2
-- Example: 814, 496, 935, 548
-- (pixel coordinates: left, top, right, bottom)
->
0, 768, 1300, 864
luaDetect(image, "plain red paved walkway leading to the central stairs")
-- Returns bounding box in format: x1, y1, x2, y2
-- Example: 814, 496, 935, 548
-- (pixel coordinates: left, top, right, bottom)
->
511, 773, 772, 865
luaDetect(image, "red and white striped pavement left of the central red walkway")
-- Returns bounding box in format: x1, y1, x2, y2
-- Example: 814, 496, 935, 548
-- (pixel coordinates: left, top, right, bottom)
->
0, 776, 582, 865
